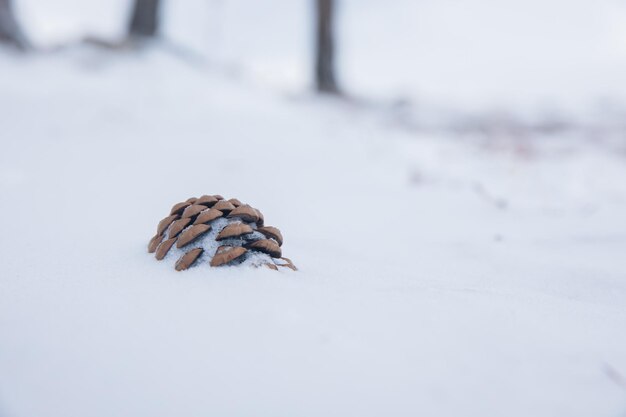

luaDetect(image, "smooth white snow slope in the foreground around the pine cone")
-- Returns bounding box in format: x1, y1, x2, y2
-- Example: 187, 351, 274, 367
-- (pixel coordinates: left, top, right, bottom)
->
0, 0, 626, 417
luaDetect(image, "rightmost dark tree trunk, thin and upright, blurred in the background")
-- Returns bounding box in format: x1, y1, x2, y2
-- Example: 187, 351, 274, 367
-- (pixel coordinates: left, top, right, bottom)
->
315, 0, 339, 94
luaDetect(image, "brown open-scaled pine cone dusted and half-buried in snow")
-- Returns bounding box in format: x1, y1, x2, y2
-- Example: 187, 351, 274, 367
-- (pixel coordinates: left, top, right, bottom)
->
148, 194, 297, 271
